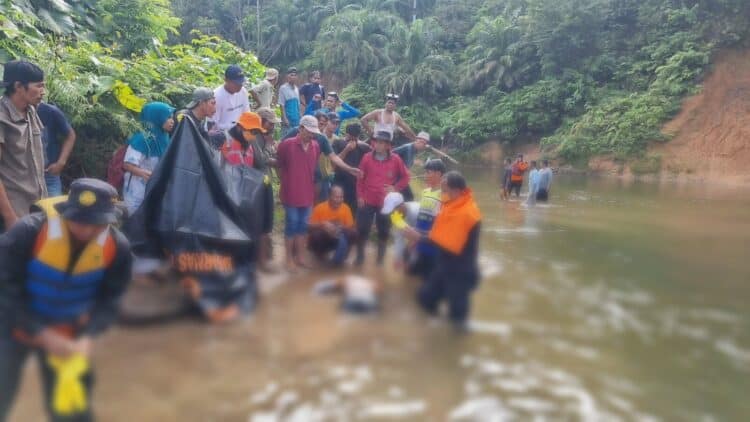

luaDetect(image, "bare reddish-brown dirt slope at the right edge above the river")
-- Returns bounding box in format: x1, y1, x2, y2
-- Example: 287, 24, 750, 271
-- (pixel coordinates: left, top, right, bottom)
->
650, 51, 750, 184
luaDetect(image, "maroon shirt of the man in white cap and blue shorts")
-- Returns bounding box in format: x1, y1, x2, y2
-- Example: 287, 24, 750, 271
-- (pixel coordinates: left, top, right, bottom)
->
277, 136, 320, 207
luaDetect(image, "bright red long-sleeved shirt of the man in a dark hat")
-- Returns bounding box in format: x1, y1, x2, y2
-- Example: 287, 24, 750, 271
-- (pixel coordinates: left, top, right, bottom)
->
357, 151, 410, 208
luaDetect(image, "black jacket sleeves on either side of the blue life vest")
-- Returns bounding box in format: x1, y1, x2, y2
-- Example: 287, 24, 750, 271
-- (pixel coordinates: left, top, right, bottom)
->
0, 213, 132, 336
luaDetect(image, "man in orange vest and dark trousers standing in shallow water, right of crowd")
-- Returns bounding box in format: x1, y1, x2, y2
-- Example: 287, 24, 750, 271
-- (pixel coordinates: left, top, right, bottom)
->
404, 171, 482, 329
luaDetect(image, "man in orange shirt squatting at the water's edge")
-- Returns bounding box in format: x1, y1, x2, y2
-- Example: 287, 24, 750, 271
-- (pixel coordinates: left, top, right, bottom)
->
307, 185, 357, 267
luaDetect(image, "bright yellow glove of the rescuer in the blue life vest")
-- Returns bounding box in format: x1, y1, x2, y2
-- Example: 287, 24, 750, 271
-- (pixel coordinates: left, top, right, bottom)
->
47, 354, 89, 416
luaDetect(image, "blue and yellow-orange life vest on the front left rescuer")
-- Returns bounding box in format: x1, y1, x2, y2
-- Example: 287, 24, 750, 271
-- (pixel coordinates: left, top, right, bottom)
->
26, 213, 115, 322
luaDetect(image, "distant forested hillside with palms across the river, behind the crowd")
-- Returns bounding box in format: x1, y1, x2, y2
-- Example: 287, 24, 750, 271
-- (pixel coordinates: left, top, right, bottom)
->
178, 0, 750, 161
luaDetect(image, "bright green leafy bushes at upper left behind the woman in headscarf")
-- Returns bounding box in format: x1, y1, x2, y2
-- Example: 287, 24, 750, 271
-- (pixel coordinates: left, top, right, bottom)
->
0, 0, 264, 177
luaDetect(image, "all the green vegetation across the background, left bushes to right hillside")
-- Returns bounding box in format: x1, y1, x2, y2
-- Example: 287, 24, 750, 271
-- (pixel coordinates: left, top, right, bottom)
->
0, 0, 750, 175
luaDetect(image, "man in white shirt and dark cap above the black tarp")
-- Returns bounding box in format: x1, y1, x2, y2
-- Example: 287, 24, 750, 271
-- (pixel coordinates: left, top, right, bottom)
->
211, 64, 250, 131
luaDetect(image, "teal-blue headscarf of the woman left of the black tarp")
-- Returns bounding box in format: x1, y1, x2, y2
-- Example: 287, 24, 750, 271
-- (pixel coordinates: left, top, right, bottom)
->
128, 102, 174, 157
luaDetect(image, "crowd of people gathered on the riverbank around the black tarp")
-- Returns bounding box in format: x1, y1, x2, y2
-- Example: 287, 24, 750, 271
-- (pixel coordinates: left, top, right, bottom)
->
0, 61, 488, 421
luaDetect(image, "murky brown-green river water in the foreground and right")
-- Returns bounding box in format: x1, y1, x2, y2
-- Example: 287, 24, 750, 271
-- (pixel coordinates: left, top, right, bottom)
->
13, 170, 750, 422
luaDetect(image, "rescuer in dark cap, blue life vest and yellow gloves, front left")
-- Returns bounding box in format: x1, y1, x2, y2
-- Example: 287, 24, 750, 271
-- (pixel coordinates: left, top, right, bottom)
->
0, 179, 131, 421
